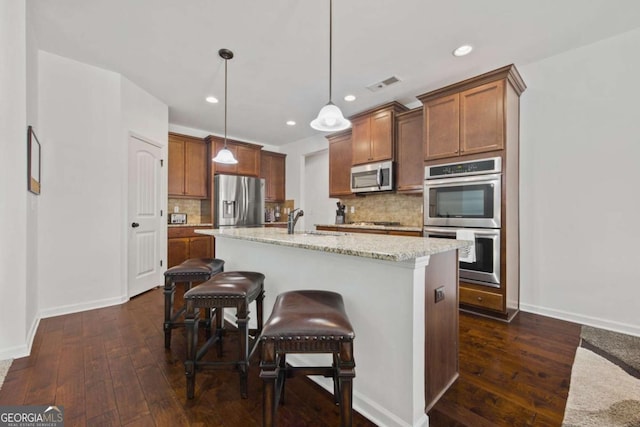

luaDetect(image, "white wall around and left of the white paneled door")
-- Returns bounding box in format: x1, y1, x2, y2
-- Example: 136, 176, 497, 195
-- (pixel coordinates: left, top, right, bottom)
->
38, 51, 168, 317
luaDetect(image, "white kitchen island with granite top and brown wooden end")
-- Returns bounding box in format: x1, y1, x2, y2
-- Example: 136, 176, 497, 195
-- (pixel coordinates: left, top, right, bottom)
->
197, 228, 468, 426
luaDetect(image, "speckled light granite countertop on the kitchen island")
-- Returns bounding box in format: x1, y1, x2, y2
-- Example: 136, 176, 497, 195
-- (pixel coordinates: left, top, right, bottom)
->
195, 227, 470, 261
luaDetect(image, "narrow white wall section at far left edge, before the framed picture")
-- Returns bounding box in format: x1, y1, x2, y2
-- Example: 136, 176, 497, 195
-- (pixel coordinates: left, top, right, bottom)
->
0, 1, 30, 359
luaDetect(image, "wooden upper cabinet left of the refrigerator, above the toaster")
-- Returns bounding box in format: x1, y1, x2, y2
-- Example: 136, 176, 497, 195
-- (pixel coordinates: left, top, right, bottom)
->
167, 133, 209, 199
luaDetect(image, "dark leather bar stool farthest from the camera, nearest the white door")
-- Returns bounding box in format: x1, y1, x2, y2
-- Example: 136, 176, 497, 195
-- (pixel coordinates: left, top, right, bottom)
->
164, 258, 224, 348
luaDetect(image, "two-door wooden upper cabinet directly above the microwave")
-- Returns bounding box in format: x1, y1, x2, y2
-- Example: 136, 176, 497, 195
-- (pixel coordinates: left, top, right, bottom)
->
350, 102, 407, 165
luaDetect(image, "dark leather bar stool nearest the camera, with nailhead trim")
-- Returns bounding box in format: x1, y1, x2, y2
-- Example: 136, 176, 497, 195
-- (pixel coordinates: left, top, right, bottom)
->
260, 290, 356, 427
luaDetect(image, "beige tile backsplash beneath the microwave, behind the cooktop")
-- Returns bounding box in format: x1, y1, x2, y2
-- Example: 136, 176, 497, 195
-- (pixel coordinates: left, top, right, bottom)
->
340, 193, 423, 227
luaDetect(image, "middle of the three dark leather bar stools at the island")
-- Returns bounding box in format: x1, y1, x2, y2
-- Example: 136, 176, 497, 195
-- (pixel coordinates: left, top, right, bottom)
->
184, 271, 264, 399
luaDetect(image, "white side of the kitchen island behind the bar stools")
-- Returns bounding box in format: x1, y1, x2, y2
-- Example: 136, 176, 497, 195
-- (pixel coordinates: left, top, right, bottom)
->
216, 236, 428, 427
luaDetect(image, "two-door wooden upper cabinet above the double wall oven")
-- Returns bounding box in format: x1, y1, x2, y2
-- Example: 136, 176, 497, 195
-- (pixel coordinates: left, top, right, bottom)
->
418, 65, 526, 161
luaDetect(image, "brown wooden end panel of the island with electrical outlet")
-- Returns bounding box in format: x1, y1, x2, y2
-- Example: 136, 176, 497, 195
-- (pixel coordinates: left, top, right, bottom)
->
424, 251, 459, 412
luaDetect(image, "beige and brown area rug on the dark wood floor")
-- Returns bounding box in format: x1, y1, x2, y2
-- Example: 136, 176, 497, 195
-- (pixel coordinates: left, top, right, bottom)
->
562, 326, 640, 427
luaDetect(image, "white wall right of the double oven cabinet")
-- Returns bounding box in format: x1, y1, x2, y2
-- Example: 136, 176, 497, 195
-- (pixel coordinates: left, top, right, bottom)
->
519, 30, 640, 335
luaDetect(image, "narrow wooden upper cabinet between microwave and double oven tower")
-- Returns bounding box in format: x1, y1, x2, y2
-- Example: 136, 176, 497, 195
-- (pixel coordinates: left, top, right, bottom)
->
396, 108, 424, 193
